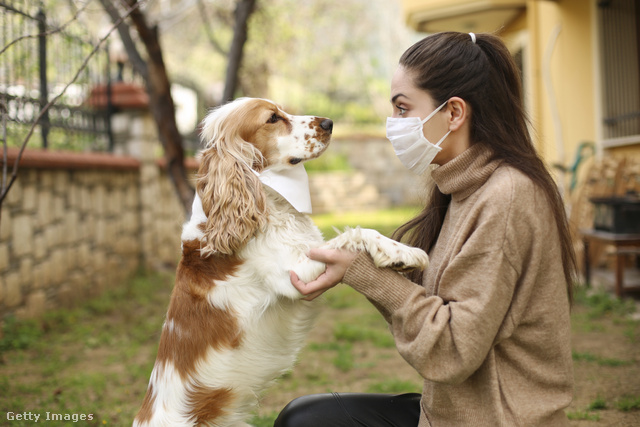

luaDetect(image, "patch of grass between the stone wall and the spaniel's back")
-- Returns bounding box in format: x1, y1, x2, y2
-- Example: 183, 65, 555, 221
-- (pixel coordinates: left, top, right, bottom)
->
0, 274, 173, 426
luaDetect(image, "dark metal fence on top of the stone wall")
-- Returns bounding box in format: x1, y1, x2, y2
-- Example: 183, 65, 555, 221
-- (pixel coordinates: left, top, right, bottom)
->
0, 0, 113, 150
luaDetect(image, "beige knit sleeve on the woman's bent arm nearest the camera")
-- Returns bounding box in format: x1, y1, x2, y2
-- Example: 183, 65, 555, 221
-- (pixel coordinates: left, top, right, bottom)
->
343, 250, 517, 383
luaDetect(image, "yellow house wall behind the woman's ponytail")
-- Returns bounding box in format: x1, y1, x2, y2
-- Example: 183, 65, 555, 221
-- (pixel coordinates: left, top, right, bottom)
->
403, 0, 640, 166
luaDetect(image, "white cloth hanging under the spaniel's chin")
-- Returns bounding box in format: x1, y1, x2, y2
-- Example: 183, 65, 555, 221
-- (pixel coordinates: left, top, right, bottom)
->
253, 163, 311, 214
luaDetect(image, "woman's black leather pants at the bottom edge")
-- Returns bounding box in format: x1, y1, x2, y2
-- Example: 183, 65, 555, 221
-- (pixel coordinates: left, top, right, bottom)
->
273, 393, 420, 427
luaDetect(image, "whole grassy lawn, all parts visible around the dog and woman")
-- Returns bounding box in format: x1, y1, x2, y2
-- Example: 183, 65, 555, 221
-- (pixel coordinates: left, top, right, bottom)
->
0, 209, 640, 427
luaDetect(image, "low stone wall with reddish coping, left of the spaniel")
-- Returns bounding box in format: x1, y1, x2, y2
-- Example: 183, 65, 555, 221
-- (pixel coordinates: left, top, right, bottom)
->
0, 115, 185, 320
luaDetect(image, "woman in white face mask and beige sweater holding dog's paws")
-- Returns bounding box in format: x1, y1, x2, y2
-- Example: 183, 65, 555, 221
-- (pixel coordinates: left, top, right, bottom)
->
275, 32, 575, 427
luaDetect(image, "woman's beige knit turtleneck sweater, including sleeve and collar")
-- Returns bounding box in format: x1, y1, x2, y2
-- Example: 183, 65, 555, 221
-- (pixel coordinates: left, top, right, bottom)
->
343, 144, 573, 427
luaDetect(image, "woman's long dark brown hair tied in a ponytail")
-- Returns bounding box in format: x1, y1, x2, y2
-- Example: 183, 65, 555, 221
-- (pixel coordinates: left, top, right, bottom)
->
393, 32, 577, 301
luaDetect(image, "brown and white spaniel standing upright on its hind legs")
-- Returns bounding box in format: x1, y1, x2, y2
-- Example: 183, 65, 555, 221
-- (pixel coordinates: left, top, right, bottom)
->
133, 98, 428, 427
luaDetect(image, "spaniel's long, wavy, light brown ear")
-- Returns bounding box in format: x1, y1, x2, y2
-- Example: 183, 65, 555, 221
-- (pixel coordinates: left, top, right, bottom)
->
196, 119, 267, 256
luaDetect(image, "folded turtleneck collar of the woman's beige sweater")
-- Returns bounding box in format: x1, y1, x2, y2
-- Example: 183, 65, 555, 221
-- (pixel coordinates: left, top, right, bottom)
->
431, 143, 501, 201
